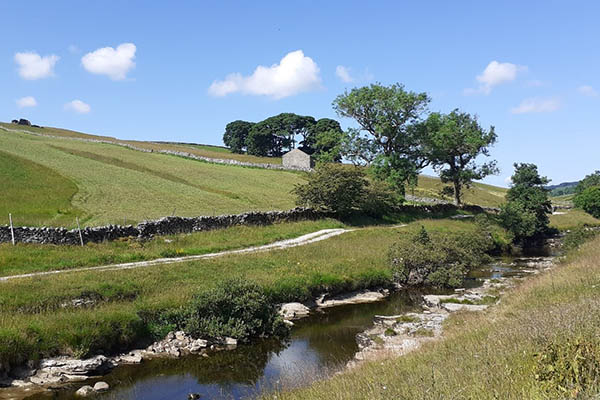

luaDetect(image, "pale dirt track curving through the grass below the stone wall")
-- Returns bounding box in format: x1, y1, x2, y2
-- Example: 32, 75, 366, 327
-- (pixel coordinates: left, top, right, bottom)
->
0, 228, 355, 282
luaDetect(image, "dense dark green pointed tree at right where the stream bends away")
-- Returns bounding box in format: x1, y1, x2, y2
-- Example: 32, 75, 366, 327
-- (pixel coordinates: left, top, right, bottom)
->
500, 164, 552, 243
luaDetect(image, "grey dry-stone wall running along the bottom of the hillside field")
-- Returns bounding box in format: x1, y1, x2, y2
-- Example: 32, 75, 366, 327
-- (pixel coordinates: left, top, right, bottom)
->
0, 208, 331, 245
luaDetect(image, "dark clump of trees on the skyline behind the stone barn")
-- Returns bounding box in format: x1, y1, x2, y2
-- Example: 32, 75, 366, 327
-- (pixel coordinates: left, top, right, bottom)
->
223, 113, 344, 162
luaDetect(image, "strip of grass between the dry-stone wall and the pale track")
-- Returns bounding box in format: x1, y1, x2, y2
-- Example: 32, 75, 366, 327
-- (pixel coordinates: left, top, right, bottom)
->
0, 219, 344, 276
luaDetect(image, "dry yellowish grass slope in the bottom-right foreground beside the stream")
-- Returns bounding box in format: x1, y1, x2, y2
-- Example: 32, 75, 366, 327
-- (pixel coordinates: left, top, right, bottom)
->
276, 238, 600, 399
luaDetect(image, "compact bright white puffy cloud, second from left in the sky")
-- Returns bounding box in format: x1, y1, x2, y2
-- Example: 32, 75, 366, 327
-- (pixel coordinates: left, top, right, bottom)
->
81, 43, 136, 81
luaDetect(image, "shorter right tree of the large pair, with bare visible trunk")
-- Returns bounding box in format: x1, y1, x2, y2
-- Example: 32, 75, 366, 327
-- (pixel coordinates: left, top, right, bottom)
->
422, 110, 498, 206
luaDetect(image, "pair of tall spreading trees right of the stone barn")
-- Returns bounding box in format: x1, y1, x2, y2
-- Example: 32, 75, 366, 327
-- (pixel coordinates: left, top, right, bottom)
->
333, 84, 497, 205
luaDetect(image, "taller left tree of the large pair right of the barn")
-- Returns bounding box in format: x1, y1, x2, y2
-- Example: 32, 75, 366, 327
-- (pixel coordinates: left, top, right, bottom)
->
333, 84, 430, 191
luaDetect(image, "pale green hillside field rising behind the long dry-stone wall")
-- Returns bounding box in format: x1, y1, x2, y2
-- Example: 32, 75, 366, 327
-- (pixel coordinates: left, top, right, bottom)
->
0, 123, 506, 227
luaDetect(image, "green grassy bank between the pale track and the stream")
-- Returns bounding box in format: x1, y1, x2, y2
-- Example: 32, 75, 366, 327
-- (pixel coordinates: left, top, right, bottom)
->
0, 220, 496, 370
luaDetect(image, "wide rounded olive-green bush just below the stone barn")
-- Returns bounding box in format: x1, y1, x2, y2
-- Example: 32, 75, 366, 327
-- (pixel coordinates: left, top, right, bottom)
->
293, 163, 402, 217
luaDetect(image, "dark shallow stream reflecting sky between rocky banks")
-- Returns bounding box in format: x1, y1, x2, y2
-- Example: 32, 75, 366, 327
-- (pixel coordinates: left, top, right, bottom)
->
27, 245, 551, 400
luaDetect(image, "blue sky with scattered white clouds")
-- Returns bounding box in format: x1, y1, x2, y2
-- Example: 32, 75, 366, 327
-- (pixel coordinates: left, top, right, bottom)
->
0, 0, 600, 185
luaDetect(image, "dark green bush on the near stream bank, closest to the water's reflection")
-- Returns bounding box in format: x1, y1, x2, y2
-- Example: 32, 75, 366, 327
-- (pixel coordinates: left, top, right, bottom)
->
184, 279, 288, 341
